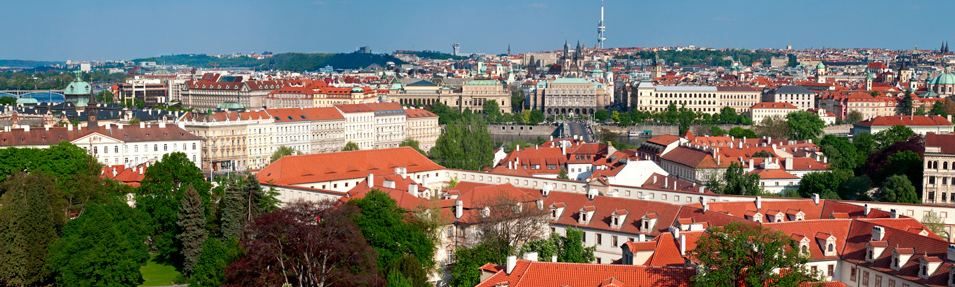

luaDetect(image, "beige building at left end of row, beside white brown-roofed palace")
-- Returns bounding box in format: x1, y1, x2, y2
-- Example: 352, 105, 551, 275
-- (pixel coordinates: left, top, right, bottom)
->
180, 112, 249, 171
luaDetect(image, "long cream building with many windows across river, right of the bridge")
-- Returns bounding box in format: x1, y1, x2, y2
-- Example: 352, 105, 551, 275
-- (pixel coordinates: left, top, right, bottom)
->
632, 82, 761, 114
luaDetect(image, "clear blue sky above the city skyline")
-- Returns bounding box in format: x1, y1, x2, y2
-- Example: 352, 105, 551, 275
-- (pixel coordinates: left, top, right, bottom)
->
0, 0, 955, 61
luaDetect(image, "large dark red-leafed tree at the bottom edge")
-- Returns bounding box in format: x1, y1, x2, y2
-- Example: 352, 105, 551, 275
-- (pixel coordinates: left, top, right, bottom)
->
224, 202, 385, 286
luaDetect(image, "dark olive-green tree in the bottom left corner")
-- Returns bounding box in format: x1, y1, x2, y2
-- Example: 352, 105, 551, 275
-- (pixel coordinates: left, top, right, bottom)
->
0, 171, 57, 286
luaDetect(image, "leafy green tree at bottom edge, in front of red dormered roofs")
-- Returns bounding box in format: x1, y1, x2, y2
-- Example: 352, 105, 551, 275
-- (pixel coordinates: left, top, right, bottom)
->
690, 222, 814, 287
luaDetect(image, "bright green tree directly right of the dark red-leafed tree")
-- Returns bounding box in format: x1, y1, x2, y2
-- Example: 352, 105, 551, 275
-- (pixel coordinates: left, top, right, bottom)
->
348, 189, 435, 276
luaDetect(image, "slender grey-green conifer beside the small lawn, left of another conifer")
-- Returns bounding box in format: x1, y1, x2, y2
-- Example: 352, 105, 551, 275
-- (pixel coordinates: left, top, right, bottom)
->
176, 186, 206, 276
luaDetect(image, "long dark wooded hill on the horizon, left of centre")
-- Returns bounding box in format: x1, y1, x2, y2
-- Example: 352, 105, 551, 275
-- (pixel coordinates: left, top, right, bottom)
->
133, 53, 404, 72
